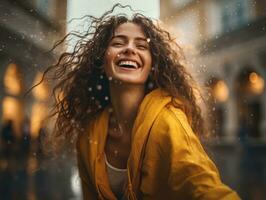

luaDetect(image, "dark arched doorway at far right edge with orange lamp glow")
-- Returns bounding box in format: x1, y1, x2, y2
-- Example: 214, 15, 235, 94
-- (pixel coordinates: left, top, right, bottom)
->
235, 67, 264, 138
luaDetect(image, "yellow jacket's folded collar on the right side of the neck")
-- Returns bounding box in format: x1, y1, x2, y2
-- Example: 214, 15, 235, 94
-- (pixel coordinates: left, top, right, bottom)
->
128, 89, 171, 195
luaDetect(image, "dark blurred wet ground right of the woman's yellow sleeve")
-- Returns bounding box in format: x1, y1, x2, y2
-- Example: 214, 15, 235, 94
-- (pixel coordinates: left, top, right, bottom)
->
208, 142, 266, 200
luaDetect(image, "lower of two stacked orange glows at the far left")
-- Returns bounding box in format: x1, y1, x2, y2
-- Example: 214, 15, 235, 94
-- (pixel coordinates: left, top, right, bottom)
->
2, 97, 23, 137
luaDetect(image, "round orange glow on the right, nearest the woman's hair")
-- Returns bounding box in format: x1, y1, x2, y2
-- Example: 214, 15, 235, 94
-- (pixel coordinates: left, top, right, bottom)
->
213, 80, 229, 102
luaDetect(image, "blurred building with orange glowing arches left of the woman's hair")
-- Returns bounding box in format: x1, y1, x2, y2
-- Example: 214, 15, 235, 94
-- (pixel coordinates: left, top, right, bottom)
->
0, 0, 67, 137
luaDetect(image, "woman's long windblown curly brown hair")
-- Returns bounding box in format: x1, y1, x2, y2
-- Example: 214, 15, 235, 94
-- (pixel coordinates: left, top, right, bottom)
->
44, 4, 204, 153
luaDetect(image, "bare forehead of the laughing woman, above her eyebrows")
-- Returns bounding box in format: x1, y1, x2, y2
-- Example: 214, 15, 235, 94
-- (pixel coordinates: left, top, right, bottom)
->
114, 22, 146, 38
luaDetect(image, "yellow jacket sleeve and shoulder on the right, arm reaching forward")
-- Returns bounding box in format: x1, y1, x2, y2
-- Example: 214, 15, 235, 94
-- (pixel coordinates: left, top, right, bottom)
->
140, 109, 239, 200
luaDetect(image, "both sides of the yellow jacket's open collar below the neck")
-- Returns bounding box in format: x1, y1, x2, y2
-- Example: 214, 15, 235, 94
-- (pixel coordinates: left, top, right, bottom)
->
90, 89, 171, 199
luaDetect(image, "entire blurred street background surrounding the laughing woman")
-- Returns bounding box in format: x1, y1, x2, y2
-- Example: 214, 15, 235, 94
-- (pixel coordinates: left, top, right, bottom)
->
0, 0, 266, 200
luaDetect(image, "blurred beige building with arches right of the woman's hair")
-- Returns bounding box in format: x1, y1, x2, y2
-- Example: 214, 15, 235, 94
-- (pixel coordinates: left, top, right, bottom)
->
160, 0, 266, 142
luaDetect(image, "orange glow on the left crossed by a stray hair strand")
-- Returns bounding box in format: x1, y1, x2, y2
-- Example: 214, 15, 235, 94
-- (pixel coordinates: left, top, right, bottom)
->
32, 73, 49, 101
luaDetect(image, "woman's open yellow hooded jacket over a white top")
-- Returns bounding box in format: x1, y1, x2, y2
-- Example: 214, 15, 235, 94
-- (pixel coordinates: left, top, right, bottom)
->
77, 89, 239, 200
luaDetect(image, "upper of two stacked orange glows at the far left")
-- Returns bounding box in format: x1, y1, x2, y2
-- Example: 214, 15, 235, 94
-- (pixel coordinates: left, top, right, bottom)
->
4, 63, 22, 95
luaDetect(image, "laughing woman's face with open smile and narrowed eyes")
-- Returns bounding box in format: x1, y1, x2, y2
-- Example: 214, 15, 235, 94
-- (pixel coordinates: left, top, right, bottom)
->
104, 22, 152, 84
